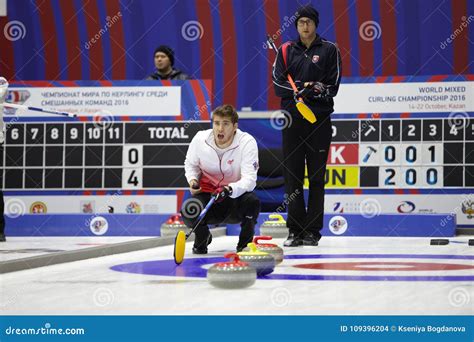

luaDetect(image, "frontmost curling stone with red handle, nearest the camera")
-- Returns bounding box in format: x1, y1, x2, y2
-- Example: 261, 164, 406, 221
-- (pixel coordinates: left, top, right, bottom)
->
207, 253, 257, 289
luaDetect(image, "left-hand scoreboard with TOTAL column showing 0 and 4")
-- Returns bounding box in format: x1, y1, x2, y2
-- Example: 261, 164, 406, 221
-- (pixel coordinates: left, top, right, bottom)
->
1, 121, 210, 190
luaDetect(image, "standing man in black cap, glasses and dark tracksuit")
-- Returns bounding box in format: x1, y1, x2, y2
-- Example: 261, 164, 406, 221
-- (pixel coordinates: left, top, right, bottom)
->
273, 6, 341, 247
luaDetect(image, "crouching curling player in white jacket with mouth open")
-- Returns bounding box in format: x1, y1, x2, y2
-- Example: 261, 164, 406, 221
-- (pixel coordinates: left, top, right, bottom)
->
181, 105, 260, 254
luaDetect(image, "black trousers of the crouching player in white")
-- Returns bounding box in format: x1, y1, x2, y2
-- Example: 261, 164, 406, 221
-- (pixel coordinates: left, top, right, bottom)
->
181, 192, 260, 249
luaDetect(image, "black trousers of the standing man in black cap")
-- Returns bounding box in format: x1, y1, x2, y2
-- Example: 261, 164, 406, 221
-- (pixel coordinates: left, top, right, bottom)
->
282, 113, 332, 238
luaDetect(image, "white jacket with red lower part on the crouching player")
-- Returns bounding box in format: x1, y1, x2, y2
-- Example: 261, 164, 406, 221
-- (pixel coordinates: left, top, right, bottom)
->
184, 129, 258, 198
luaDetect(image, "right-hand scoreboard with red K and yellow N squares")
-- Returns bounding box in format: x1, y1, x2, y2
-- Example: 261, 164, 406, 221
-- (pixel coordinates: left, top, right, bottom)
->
312, 117, 474, 188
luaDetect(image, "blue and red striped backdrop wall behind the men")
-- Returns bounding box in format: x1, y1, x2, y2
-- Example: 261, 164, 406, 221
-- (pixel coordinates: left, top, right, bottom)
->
0, 0, 474, 110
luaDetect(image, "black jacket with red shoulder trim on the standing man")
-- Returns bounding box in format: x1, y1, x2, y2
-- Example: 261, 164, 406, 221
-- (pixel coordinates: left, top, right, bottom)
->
272, 35, 342, 117
